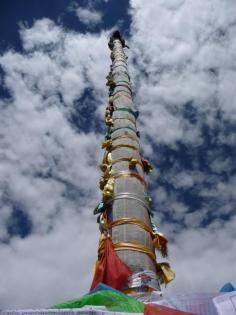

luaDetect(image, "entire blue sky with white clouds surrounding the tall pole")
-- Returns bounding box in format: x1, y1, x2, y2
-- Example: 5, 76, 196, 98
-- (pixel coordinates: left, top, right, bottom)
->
0, 0, 236, 308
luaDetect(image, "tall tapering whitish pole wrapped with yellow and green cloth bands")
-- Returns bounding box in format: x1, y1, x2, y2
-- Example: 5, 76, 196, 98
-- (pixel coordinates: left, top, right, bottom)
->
96, 31, 175, 295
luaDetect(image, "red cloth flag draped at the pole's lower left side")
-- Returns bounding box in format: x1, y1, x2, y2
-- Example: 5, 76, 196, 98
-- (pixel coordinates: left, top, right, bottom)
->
90, 238, 132, 290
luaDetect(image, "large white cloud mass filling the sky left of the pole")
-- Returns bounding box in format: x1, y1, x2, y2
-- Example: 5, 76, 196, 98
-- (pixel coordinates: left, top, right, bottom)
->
0, 19, 109, 308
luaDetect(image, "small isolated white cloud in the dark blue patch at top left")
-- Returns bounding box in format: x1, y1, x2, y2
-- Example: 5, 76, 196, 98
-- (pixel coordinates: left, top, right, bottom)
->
76, 7, 102, 27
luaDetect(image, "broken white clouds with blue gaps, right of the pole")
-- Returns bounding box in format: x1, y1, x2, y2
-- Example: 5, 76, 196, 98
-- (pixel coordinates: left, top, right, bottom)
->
129, 0, 236, 294
